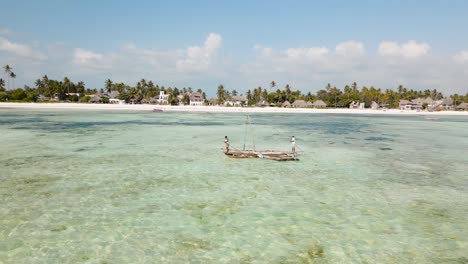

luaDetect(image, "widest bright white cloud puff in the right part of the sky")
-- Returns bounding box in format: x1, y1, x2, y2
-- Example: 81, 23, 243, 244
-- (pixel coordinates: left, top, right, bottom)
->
377, 40, 431, 59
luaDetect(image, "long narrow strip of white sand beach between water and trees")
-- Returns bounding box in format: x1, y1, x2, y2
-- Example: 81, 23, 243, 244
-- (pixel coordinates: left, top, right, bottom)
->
0, 102, 468, 116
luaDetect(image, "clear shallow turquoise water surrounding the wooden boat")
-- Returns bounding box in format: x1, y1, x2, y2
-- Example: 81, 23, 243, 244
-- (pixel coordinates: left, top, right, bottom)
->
0, 109, 468, 263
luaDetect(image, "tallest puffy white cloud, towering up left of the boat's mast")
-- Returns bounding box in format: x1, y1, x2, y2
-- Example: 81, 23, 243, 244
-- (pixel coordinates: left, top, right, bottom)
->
176, 33, 221, 72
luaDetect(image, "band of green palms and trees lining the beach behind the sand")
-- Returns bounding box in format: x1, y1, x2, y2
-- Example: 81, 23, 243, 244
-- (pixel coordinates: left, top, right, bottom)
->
0, 65, 468, 108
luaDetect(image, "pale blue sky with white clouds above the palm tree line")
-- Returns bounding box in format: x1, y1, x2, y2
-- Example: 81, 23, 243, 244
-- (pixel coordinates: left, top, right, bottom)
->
0, 0, 468, 96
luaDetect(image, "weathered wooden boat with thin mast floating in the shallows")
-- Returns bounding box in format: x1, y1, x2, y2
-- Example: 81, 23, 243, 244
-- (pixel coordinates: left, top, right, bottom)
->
224, 115, 299, 161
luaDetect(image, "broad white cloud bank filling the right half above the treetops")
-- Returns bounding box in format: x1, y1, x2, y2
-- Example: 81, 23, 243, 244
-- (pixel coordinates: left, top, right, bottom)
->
239, 41, 468, 93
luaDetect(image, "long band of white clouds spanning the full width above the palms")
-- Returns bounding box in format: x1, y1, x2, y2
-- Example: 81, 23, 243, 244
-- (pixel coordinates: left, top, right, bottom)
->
0, 33, 468, 95
